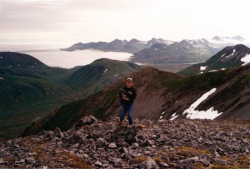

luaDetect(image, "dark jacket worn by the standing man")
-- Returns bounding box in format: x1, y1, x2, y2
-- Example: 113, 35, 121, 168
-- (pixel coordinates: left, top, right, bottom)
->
119, 86, 136, 105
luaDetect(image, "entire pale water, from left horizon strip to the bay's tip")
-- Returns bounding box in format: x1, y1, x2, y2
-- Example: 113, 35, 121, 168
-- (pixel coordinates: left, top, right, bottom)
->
0, 44, 132, 69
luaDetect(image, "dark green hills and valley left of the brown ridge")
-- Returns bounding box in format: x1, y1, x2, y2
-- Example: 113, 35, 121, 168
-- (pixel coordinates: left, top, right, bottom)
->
0, 52, 141, 140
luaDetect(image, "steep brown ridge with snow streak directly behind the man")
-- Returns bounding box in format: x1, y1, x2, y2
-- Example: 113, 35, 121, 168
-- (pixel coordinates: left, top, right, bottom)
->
23, 66, 250, 135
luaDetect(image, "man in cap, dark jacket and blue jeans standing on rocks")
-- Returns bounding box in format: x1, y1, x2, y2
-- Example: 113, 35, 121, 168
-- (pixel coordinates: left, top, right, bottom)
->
118, 77, 136, 126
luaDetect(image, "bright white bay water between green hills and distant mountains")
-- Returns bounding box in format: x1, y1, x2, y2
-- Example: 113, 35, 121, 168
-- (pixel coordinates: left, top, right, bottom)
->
22, 49, 132, 69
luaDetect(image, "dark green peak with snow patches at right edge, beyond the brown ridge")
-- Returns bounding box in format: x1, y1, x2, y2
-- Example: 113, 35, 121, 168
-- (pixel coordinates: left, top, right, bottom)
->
178, 44, 250, 76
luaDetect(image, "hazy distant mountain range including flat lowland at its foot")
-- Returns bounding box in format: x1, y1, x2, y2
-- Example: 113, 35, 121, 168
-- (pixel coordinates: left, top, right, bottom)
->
61, 36, 246, 72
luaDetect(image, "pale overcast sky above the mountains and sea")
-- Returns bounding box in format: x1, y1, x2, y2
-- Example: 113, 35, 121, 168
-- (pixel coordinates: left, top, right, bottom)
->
0, 0, 250, 47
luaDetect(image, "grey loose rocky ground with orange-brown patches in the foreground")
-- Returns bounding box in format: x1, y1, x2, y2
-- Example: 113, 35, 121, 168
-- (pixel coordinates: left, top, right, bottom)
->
0, 117, 250, 169
